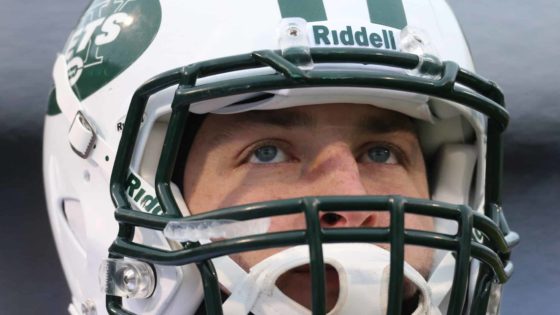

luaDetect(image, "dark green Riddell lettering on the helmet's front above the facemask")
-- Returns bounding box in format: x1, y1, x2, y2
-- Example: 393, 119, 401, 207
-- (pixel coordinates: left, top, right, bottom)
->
313, 25, 397, 50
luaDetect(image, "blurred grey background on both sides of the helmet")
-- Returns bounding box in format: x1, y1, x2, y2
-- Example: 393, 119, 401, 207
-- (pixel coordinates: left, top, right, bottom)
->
0, 0, 560, 315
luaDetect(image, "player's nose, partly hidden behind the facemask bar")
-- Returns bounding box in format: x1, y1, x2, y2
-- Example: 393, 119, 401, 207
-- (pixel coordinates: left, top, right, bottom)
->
305, 143, 377, 227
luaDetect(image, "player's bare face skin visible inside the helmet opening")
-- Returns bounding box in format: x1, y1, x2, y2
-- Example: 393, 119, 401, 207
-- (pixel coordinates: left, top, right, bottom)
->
183, 104, 433, 309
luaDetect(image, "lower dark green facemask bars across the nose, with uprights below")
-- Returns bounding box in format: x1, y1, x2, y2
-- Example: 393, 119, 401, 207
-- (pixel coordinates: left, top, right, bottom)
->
111, 196, 513, 314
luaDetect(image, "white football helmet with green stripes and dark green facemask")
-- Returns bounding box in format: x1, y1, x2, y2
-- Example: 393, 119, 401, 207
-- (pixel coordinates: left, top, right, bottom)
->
43, 0, 519, 315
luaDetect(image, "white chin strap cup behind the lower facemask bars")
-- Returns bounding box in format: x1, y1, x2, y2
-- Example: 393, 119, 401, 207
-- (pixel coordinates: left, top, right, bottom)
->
213, 244, 440, 315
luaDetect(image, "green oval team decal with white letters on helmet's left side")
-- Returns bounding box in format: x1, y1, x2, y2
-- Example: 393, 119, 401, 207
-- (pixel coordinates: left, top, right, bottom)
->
64, 0, 161, 100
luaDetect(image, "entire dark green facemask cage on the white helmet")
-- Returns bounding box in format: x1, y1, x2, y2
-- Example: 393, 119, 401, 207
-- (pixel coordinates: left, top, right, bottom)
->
107, 48, 518, 314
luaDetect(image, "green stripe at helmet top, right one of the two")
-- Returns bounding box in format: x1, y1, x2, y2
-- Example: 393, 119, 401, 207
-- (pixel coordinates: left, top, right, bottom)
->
367, 0, 407, 29
